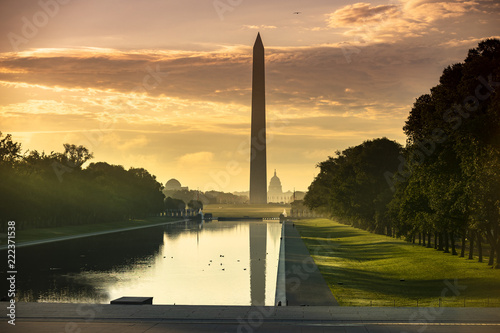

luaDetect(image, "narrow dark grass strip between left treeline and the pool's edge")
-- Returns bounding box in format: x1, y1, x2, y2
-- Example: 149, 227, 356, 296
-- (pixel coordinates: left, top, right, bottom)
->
0, 217, 181, 245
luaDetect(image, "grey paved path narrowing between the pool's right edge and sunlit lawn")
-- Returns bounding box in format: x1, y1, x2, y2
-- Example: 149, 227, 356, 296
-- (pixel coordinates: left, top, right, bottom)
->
285, 222, 339, 306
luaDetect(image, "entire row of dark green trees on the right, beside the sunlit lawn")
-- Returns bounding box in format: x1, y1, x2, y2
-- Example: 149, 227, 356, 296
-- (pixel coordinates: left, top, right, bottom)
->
305, 39, 500, 268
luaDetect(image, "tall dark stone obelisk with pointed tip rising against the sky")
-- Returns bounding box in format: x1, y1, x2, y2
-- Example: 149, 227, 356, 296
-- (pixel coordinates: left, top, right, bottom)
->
250, 33, 267, 204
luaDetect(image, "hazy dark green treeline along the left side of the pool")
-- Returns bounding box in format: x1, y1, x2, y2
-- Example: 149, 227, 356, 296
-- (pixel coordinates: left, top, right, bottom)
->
0, 138, 165, 231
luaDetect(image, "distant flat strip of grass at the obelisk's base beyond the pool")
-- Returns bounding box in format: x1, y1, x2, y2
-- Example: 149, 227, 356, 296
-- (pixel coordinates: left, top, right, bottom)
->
203, 204, 290, 217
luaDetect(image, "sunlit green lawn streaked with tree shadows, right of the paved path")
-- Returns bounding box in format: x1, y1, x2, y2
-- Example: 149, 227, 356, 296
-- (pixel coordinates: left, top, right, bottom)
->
295, 219, 500, 307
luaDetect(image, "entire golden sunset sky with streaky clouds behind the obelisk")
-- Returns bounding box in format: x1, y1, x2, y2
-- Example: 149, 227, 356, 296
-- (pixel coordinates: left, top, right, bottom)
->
0, 0, 500, 192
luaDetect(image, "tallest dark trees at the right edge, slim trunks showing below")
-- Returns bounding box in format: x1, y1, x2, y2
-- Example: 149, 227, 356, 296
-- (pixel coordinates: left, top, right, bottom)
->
404, 39, 500, 264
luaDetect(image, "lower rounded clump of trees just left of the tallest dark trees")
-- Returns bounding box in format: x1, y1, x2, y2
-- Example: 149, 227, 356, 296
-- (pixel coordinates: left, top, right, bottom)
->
305, 138, 401, 233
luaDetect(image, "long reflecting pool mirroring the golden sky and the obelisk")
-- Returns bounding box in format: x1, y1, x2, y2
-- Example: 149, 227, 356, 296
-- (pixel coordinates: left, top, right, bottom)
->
12, 221, 281, 305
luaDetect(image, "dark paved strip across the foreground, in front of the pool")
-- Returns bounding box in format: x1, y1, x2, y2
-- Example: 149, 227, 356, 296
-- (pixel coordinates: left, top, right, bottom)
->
0, 302, 500, 333
